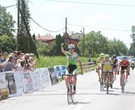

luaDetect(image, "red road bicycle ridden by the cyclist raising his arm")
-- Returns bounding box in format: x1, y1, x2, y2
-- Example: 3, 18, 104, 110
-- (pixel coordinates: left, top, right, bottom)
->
64, 74, 76, 104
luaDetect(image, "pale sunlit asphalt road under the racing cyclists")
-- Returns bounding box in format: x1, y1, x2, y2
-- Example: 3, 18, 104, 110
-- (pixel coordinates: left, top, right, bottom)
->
0, 70, 135, 110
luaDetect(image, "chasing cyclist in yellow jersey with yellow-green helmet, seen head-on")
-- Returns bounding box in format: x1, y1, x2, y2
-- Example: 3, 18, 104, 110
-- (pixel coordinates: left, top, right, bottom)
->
102, 54, 113, 88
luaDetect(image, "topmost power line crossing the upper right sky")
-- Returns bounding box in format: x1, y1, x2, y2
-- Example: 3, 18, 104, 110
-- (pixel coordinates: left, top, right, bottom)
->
46, 0, 135, 7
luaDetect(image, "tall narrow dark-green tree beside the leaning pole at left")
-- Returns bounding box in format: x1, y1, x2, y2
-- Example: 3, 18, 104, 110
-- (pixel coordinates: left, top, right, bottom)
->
17, 0, 30, 52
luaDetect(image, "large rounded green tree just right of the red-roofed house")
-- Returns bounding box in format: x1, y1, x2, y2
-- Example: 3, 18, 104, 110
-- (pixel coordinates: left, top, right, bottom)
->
78, 31, 110, 57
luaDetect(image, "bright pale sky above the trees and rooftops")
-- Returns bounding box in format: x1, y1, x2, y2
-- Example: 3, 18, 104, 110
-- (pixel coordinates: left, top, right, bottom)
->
0, 0, 135, 48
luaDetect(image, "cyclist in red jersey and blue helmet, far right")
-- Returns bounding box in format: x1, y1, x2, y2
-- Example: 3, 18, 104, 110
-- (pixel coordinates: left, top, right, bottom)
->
119, 56, 130, 84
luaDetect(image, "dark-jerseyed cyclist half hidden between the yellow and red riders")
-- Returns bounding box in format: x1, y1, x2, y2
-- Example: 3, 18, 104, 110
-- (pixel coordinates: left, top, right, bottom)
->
112, 55, 118, 80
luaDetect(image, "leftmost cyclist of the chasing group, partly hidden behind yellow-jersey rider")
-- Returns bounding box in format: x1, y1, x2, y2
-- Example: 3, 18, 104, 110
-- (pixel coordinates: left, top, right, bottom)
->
96, 53, 104, 81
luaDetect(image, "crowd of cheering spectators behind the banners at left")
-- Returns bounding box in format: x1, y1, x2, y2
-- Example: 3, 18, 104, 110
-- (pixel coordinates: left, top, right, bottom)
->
0, 51, 37, 72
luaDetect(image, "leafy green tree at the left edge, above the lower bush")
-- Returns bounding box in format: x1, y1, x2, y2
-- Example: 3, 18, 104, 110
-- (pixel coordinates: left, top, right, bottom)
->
0, 5, 15, 36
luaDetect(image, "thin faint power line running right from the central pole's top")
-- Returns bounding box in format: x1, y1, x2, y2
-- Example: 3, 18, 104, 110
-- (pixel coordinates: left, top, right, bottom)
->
68, 23, 131, 32
